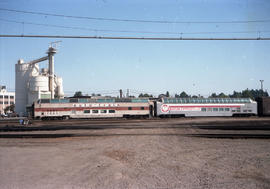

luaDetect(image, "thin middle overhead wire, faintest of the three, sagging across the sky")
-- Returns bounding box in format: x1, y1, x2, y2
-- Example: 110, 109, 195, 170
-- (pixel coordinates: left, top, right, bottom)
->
0, 18, 270, 35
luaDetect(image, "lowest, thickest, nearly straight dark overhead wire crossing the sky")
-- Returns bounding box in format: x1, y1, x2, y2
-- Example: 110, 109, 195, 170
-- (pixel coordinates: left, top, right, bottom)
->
0, 34, 270, 41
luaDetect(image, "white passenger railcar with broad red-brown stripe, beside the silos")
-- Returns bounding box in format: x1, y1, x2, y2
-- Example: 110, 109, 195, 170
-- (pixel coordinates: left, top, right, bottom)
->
34, 98, 152, 119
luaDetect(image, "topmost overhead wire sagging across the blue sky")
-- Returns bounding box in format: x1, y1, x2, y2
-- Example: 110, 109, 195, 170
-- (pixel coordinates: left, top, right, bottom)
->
0, 8, 270, 24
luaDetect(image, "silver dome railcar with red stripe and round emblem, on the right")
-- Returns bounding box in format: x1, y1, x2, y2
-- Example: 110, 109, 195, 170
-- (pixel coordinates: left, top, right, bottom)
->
155, 98, 257, 117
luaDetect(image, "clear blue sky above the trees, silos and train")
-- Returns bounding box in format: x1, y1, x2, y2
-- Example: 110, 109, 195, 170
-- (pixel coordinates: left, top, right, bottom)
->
0, 0, 270, 96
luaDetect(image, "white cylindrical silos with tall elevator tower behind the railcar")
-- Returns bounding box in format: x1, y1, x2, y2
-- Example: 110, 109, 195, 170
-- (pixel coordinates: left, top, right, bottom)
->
15, 47, 64, 116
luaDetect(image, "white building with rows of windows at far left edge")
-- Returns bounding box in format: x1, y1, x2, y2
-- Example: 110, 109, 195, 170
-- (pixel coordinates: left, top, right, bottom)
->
0, 85, 15, 114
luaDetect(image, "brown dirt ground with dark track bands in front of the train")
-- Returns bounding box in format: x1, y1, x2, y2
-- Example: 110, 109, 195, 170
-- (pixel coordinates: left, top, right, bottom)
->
0, 118, 270, 189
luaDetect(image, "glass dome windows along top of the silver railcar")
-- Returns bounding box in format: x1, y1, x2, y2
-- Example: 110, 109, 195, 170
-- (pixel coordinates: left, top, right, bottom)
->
162, 98, 252, 104
